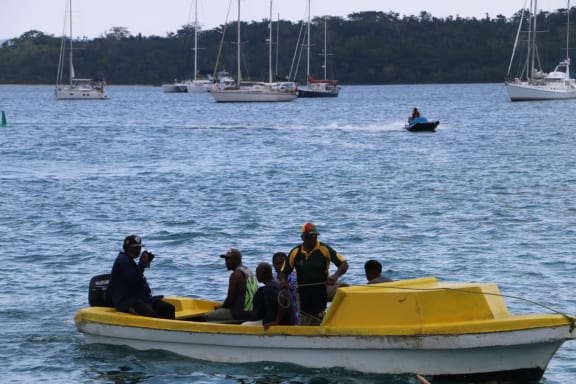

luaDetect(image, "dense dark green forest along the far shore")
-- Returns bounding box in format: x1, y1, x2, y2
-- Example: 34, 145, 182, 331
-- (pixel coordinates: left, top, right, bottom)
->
0, 8, 576, 84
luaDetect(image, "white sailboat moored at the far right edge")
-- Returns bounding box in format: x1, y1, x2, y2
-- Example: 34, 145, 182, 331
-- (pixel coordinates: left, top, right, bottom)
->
505, 0, 576, 101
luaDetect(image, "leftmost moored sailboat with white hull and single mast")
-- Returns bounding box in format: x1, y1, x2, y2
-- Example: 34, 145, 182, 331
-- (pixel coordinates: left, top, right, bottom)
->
54, 0, 108, 100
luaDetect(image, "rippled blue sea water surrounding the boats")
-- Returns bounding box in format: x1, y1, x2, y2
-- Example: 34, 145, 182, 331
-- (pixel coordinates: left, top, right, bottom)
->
0, 84, 576, 384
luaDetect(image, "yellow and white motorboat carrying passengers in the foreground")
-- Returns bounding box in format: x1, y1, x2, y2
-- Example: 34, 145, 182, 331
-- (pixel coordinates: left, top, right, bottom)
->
74, 277, 575, 382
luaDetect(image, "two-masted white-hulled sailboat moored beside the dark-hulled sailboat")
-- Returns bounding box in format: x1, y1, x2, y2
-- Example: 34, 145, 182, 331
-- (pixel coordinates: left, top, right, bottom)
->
210, 0, 298, 103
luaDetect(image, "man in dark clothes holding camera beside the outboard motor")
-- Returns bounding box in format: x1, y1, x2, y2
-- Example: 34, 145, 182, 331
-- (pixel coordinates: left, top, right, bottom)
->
108, 235, 175, 319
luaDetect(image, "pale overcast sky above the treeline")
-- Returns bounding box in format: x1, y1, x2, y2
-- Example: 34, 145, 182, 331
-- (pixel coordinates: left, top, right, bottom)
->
0, 0, 576, 39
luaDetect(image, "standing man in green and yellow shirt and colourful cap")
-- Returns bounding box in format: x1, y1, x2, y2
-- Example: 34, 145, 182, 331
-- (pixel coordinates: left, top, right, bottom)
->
278, 223, 348, 325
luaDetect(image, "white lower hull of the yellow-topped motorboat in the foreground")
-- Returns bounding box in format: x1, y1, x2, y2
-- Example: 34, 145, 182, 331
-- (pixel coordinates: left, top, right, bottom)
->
78, 320, 570, 376
